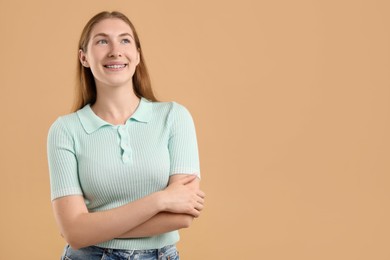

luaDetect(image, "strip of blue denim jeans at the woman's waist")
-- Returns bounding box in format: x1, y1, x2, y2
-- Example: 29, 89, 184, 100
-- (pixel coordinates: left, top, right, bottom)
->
61, 245, 179, 260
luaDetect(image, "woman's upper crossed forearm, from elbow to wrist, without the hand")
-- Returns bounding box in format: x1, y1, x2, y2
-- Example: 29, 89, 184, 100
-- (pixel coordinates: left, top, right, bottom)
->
53, 193, 161, 249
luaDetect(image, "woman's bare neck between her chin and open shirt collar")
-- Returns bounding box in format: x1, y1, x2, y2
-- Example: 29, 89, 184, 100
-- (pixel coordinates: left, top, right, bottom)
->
91, 82, 140, 125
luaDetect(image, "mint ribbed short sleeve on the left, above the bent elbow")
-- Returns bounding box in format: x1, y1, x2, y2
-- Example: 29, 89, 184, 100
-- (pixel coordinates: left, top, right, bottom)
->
47, 118, 83, 200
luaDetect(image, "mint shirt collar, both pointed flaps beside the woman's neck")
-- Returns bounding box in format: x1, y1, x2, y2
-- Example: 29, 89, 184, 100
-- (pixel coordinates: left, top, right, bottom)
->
76, 98, 152, 134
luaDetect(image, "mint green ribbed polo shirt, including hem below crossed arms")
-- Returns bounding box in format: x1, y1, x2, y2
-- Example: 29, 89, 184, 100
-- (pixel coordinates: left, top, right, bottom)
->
48, 98, 200, 250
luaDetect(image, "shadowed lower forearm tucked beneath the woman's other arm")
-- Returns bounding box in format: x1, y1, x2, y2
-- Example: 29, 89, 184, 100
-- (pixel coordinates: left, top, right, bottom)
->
118, 212, 193, 238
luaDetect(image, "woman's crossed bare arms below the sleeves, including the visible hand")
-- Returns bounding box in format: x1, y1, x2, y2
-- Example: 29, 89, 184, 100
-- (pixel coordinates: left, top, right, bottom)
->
53, 176, 204, 249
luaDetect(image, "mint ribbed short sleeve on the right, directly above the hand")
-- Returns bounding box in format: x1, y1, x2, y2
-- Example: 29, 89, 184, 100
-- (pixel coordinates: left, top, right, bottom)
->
168, 103, 200, 177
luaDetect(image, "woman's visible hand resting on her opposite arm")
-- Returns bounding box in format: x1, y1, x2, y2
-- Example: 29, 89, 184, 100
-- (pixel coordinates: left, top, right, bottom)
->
162, 175, 205, 217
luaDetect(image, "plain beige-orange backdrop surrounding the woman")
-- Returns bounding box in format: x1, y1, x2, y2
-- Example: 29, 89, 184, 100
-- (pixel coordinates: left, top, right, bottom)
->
0, 0, 390, 260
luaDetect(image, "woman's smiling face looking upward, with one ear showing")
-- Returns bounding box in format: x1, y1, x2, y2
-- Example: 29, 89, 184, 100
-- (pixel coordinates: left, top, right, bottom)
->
79, 18, 140, 87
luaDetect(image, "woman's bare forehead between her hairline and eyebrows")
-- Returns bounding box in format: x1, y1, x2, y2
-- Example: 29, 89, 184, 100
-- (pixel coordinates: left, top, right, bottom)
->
90, 18, 133, 37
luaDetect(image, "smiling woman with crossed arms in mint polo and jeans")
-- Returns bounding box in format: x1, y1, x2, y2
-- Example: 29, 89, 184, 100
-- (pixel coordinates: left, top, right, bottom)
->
48, 12, 204, 260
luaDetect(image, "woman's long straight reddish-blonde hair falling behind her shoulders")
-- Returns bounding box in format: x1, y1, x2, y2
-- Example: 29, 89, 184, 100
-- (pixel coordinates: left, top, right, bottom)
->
72, 11, 157, 111
